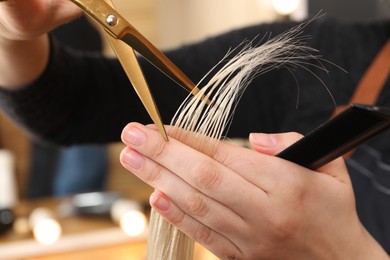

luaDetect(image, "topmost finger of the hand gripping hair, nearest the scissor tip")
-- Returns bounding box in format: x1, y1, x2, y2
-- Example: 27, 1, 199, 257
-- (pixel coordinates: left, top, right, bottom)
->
122, 123, 267, 212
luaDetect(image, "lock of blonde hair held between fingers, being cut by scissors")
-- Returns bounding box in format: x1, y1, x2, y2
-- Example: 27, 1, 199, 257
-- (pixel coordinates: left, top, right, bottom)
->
147, 19, 323, 260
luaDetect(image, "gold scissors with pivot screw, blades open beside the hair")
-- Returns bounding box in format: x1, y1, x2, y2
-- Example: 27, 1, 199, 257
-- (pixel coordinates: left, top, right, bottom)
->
71, 0, 199, 141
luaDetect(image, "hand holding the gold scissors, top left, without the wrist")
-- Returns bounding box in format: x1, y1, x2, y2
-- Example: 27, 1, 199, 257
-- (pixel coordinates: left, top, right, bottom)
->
0, 0, 82, 40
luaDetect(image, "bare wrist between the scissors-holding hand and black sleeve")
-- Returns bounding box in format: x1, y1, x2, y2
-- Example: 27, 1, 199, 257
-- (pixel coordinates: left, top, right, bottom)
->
0, 34, 50, 89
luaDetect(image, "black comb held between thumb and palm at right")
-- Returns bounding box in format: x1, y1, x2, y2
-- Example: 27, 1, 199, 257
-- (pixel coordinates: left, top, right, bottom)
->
277, 104, 390, 170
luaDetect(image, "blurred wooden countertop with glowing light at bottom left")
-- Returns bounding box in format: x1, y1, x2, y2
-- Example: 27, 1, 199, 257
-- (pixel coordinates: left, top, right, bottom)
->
0, 198, 217, 260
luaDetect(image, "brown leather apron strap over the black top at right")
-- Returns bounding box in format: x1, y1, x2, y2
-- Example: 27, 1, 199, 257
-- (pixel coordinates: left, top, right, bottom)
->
333, 40, 390, 115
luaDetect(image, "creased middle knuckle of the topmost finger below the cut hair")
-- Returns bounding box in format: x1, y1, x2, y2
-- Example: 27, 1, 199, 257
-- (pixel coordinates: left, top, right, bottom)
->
191, 162, 222, 191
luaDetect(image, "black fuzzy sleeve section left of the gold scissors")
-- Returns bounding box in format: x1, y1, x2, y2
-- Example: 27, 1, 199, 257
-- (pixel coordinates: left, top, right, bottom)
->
0, 37, 147, 145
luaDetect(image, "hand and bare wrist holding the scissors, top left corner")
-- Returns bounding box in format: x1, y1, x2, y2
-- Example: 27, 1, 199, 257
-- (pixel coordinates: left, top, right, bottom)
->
0, 0, 81, 88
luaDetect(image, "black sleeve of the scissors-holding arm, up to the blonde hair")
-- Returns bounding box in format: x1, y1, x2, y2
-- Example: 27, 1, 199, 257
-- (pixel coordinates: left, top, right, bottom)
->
0, 20, 298, 145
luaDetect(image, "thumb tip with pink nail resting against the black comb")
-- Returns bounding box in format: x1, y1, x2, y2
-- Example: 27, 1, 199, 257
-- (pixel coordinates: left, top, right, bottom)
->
249, 132, 303, 155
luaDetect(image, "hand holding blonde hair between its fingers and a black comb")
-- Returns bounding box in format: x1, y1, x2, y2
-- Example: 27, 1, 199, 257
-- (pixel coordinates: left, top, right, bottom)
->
121, 123, 388, 259
